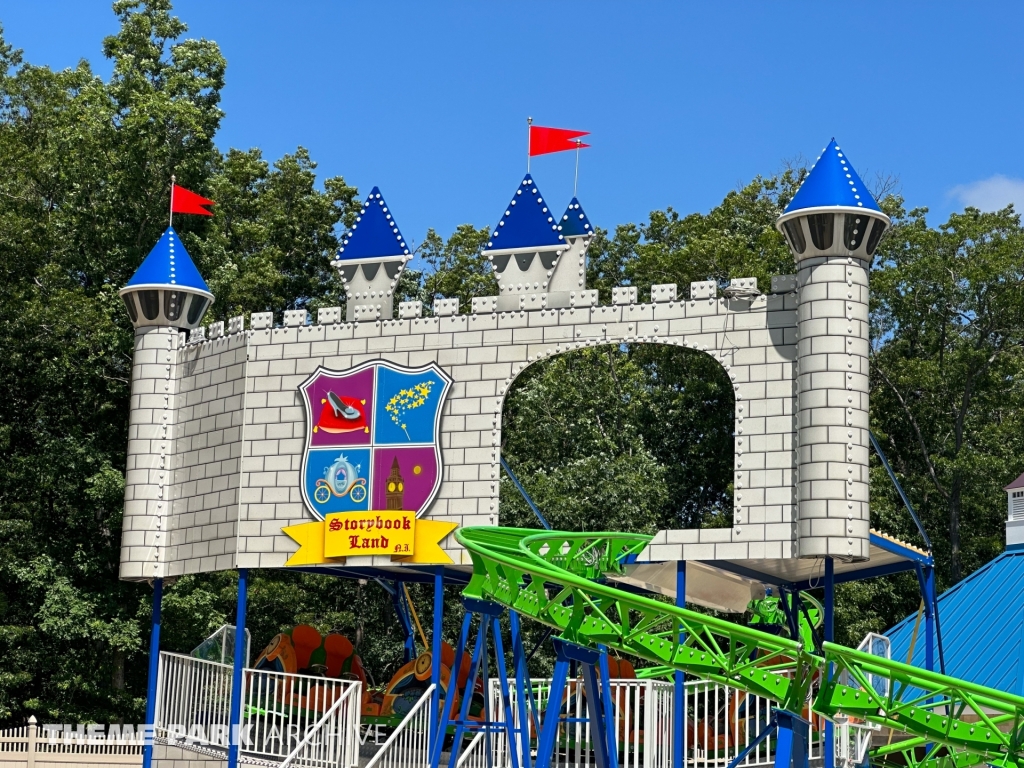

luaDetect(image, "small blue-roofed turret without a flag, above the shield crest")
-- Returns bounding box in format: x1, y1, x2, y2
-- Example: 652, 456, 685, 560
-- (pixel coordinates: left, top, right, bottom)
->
331, 186, 413, 322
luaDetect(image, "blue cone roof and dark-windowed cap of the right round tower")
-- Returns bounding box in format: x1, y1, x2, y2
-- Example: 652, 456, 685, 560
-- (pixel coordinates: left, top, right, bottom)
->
775, 138, 889, 259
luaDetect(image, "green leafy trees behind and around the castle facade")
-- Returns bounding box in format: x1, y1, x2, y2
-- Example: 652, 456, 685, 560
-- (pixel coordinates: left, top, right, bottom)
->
0, 0, 1024, 722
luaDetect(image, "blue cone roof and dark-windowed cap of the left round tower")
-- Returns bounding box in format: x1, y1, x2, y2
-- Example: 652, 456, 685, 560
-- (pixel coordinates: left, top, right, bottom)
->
119, 226, 213, 330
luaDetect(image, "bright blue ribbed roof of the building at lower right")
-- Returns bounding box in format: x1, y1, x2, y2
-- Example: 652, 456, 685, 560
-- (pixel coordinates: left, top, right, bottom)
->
886, 547, 1024, 695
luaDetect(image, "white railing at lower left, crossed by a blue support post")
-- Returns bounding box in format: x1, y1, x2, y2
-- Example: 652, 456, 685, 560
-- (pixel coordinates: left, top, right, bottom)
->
155, 651, 362, 768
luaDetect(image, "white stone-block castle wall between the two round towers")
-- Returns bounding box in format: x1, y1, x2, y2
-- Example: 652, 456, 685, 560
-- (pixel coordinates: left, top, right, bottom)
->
122, 278, 806, 579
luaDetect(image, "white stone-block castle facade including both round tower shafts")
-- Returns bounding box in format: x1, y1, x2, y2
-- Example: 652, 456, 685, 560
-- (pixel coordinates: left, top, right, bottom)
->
121, 274, 851, 580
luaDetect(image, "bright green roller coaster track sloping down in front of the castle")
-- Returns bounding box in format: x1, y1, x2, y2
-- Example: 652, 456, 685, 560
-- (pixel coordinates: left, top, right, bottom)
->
456, 527, 1024, 768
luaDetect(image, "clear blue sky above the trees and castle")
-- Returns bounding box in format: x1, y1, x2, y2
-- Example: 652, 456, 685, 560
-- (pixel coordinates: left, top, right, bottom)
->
0, 0, 1024, 249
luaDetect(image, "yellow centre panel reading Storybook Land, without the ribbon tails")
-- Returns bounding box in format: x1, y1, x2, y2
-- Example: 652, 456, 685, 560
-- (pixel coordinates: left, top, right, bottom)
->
324, 512, 416, 557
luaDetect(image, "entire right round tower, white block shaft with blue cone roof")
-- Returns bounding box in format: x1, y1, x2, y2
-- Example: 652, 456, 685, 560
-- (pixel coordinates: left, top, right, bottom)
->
776, 140, 889, 560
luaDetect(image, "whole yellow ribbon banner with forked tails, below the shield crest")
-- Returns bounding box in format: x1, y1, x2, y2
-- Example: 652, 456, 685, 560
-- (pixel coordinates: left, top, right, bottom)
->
282, 512, 457, 565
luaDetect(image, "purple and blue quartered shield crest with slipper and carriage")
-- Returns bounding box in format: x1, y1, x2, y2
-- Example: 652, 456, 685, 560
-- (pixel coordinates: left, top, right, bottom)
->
299, 360, 452, 520
